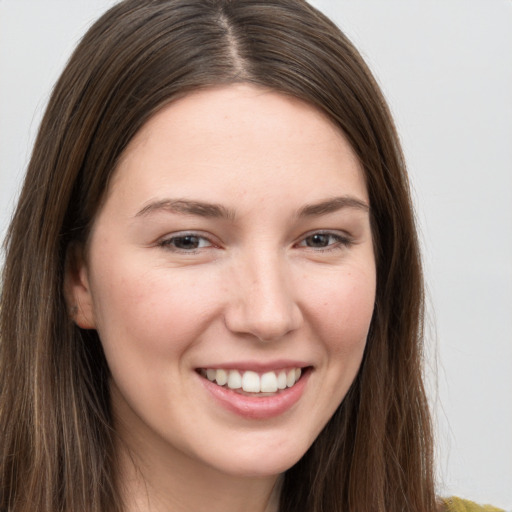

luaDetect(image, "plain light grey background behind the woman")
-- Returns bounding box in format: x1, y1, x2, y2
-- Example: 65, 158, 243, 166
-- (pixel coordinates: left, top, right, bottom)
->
0, 0, 512, 509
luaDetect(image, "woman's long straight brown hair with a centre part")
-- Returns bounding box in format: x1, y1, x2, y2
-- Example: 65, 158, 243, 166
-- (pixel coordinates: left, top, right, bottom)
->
0, 0, 435, 512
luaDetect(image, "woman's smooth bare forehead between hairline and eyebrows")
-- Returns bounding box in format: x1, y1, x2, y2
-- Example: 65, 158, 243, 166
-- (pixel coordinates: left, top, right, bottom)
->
111, 84, 368, 211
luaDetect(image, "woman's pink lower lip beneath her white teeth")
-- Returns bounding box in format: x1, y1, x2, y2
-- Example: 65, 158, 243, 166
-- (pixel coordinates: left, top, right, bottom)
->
198, 370, 311, 420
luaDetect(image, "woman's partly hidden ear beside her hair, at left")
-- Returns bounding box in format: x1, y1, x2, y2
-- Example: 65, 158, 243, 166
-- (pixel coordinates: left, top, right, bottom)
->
64, 244, 96, 329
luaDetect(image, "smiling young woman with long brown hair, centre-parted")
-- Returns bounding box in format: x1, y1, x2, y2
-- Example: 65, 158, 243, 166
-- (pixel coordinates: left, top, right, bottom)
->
0, 0, 504, 512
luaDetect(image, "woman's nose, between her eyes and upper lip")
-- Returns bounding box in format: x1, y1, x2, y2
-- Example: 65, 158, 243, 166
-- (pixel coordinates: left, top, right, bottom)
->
225, 251, 303, 341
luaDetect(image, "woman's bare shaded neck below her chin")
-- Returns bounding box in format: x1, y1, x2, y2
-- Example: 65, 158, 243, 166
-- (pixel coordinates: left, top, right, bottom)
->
117, 420, 281, 512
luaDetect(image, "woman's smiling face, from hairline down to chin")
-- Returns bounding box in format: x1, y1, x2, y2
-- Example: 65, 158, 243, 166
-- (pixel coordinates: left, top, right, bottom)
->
68, 85, 376, 476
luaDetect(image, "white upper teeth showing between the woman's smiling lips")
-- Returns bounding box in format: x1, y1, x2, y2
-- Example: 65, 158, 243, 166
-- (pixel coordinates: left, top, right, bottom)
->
198, 368, 308, 397
